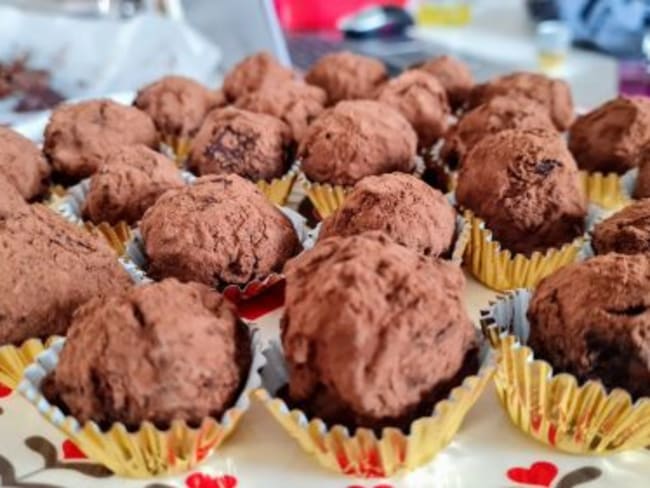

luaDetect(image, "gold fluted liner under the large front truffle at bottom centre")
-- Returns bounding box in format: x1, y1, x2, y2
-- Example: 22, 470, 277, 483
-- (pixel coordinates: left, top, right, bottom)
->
255, 342, 494, 478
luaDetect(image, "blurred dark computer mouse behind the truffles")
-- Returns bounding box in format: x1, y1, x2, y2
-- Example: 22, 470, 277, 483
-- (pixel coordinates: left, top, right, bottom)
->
338, 5, 413, 39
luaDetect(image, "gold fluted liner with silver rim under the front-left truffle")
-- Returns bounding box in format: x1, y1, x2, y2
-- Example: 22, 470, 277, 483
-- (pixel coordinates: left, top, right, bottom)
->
18, 334, 266, 478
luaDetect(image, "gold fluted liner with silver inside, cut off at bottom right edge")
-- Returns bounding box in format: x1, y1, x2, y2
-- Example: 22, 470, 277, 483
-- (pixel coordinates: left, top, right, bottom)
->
481, 290, 650, 455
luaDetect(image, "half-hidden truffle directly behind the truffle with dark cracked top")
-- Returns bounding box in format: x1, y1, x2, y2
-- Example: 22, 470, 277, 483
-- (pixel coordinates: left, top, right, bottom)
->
235, 81, 327, 141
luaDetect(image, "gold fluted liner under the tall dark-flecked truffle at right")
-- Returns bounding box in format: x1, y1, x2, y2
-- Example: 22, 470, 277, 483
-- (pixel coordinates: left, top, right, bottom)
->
465, 211, 585, 291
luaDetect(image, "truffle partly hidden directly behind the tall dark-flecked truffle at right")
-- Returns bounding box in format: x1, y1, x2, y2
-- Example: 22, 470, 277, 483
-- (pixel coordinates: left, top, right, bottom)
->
441, 95, 555, 167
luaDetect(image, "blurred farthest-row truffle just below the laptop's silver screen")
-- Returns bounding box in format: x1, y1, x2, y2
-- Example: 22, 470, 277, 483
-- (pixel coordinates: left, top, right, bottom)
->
222, 52, 295, 102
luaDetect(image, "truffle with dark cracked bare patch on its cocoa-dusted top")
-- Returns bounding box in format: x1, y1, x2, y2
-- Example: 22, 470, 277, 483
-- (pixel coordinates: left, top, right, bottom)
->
187, 107, 292, 181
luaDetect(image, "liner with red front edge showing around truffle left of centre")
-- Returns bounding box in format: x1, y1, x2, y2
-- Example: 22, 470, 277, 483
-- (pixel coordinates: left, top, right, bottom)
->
122, 207, 310, 302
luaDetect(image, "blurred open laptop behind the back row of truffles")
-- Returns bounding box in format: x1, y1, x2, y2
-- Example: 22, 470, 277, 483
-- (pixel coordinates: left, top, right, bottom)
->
184, 0, 508, 80
